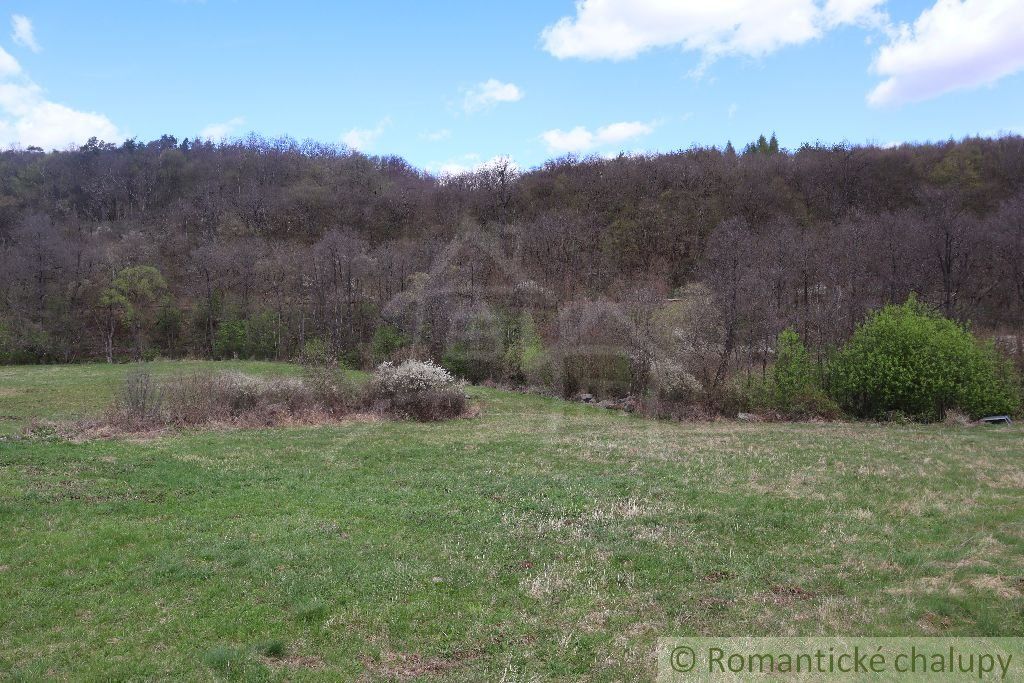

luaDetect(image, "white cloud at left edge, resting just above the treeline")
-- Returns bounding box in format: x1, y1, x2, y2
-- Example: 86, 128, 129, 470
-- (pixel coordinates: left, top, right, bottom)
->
0, 48, 123, 150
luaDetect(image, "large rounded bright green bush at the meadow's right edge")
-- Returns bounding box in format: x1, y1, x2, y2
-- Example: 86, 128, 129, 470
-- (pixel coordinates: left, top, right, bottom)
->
828, 298, 1020, 421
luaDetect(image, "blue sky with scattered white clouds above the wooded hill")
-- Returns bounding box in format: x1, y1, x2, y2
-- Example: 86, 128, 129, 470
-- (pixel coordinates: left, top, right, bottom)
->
0, 0, 1024, 173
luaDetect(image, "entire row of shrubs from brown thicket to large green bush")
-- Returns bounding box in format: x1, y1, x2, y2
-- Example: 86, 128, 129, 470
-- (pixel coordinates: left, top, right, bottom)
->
108, 298, 1021, 426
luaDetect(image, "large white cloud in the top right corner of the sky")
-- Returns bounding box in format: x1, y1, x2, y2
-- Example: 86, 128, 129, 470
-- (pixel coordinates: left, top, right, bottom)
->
867, 0, 1024, 106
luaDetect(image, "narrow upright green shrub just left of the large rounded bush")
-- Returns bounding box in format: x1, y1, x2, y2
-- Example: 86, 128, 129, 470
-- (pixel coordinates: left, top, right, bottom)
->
745, 329, 839, 419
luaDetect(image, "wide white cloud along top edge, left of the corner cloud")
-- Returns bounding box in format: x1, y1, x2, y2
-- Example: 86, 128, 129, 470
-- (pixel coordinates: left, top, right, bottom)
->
541, 0, 885, 62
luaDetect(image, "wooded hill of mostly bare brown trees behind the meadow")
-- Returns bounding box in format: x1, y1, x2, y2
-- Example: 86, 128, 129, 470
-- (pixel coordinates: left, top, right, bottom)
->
0, 136, 1024, 368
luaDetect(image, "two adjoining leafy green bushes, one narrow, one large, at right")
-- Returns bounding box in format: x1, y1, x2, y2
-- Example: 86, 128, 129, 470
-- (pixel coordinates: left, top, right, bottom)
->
744, 298, 1020, 422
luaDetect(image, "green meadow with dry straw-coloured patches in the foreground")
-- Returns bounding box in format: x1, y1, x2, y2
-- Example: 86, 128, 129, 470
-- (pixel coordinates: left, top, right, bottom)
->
0, 362, 1024, 681
